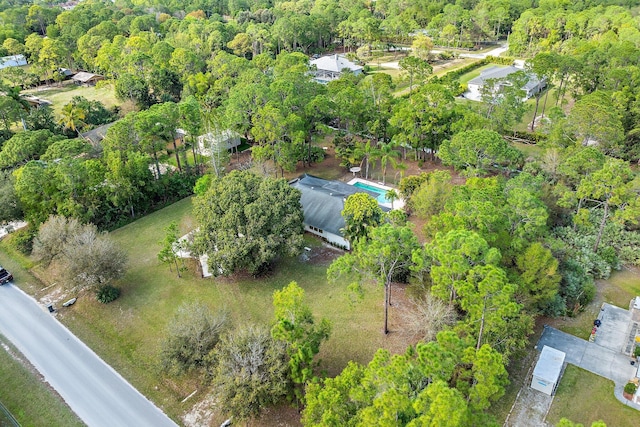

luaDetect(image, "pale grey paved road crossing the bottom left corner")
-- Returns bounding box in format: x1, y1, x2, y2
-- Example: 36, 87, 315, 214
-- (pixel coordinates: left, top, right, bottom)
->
0, 284, 176, 427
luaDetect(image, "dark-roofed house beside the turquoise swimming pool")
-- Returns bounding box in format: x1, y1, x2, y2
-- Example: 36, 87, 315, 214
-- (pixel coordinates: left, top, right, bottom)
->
289, 174, 385, 249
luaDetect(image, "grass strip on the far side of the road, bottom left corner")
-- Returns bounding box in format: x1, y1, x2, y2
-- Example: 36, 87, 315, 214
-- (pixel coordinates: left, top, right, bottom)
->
0, 335, 84, 427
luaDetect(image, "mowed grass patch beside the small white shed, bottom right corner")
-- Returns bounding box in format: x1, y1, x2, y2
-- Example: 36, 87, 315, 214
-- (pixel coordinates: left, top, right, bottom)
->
546, 365, 640, 427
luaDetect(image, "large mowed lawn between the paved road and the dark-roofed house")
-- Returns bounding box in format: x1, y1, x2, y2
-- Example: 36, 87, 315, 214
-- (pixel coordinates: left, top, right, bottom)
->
53, 199, 399, 420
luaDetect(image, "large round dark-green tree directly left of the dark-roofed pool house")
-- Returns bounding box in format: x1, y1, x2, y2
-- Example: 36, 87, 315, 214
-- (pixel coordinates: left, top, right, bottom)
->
194, 171, 303, 275
